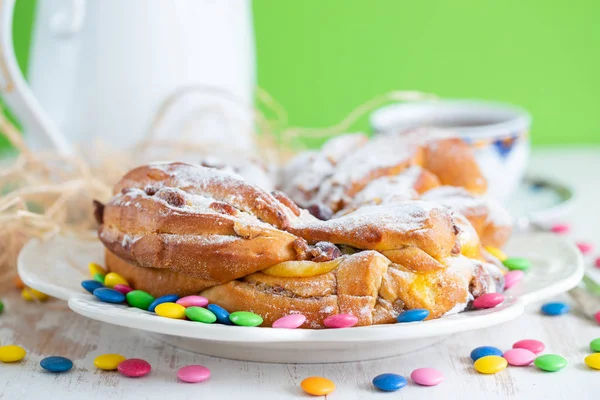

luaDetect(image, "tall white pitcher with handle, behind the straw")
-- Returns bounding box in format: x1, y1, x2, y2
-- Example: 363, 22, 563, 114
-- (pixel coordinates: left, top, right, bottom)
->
0, 0, 255, 152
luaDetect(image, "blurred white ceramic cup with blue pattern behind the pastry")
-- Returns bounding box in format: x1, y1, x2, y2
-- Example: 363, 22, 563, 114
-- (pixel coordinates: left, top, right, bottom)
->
370, 100, 531, 200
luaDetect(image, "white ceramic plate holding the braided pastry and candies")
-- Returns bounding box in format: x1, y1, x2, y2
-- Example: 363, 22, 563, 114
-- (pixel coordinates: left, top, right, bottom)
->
19, 233, 584, 363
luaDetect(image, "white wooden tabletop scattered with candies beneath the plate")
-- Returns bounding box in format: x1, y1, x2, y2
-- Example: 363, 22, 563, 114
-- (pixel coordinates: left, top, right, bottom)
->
0, 149, 600, 400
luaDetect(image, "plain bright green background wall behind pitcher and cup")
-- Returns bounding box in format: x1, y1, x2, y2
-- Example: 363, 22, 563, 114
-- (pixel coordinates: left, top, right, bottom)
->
4, 0, 600, 144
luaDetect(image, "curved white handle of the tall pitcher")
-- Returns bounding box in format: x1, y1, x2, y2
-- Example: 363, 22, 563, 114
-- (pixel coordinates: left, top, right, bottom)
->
0, 0, 73, 155
